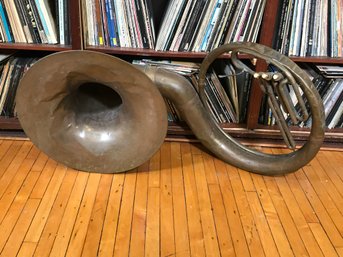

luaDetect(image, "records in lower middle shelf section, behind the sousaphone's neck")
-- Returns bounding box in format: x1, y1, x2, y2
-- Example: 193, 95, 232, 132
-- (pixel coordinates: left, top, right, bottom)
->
134, 60, 251, 123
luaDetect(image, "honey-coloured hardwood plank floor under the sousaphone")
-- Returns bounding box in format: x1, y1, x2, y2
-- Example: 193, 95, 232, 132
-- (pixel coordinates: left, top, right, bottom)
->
0, 140, 343, 257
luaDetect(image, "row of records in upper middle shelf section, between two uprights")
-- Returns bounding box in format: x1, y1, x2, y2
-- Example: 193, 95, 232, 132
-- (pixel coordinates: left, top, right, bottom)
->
82, 0, 267, 51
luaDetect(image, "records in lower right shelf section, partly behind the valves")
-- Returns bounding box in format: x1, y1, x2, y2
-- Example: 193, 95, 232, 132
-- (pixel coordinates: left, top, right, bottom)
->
259, 64, 343, 129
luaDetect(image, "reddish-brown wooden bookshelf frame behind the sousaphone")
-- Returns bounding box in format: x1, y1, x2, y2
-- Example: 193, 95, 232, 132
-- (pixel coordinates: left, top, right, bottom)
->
0, 0, 343, 146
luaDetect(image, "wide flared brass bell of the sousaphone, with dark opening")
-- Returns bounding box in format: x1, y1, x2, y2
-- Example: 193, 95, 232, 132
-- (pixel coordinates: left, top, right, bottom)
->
16, 51, 167, 173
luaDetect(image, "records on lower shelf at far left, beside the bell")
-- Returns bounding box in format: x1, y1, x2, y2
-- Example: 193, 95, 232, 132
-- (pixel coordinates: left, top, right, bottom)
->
0, 56, 37, 117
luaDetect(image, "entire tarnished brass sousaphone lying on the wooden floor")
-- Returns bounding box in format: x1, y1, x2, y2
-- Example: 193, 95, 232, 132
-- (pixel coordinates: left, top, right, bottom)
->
16, 43, 325, 175
